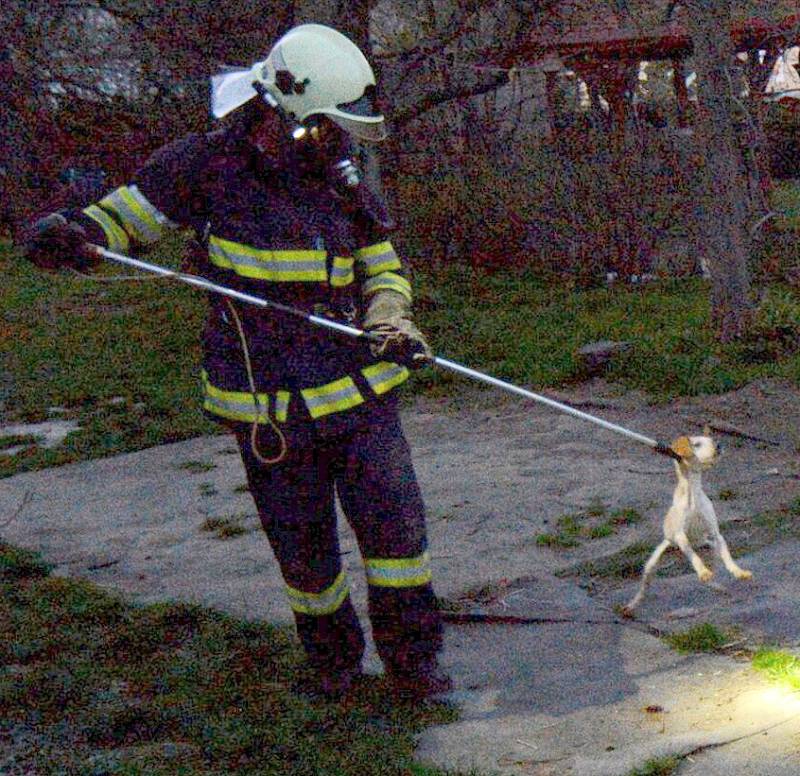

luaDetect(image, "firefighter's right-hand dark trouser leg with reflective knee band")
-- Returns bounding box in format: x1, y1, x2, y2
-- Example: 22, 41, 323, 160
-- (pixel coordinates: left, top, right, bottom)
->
337, 409, 442, 671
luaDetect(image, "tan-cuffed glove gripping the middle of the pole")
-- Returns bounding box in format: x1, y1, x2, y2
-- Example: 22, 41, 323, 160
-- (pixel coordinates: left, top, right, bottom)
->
363, 289, 433, 369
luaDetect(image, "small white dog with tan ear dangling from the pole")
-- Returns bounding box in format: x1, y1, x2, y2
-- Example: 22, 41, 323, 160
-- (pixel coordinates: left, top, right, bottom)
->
622, 426, 752, 617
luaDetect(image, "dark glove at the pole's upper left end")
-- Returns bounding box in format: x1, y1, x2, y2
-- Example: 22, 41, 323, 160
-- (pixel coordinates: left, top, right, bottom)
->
24, 213, 100, 270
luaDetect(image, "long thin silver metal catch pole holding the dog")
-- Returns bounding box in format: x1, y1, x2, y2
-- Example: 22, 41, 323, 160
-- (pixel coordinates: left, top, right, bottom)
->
92, 246, 680, 460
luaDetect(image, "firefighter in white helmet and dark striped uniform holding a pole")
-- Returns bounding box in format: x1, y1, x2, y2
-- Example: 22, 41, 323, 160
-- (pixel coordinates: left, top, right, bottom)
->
26, 24, 451, 699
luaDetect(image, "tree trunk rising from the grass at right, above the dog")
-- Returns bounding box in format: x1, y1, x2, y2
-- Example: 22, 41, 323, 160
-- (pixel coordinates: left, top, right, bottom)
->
686, 0, 752, 342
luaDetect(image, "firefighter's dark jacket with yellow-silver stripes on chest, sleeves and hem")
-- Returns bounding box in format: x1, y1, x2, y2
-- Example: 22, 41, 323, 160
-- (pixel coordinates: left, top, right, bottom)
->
77, 132, 411, 440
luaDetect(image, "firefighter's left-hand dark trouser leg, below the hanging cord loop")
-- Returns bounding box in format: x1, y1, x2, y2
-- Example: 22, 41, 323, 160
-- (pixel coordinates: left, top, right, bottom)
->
236, 431, 364, 671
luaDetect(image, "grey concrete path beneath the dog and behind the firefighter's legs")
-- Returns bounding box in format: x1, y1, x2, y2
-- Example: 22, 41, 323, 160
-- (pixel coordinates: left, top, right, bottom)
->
0, 378, 800, 776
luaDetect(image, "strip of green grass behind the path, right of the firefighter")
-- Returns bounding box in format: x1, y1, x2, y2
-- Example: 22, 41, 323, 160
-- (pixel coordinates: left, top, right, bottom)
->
406, 267, 800, 401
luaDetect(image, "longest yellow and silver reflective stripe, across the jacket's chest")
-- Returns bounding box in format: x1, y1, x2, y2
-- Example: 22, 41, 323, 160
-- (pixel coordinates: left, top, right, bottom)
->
208, 236, 328, 283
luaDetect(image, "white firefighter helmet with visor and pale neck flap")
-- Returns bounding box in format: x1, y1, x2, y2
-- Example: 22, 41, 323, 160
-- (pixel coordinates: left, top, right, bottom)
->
212, 24, 386, 140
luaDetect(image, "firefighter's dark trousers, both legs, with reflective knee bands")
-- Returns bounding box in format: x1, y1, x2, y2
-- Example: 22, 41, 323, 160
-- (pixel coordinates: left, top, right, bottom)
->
237, 408, 442, 674
